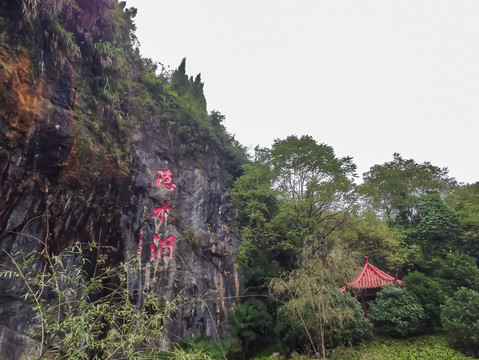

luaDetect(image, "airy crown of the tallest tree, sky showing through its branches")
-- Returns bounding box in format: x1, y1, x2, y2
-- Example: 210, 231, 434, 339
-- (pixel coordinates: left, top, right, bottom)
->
259, 136, 356, 250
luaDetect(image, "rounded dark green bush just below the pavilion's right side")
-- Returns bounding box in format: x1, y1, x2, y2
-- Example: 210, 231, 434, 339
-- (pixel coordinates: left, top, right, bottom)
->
369, 285, 425, 337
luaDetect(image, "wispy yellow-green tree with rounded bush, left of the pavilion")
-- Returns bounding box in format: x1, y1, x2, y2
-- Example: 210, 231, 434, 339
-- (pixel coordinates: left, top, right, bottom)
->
271, 244, 369, 358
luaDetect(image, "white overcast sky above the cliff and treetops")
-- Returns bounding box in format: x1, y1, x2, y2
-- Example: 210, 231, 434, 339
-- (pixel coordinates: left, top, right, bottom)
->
127, 0, 479, 183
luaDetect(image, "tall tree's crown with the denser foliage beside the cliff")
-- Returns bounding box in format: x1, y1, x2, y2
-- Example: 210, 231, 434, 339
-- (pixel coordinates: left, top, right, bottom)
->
233, 136, 356, 268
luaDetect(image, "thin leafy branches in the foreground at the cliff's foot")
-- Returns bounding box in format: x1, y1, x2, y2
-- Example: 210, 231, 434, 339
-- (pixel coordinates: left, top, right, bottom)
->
0, 244, 194, 359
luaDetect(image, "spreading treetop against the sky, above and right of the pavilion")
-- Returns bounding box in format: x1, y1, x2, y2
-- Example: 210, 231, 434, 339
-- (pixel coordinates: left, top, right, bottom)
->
361, 153, 457, 224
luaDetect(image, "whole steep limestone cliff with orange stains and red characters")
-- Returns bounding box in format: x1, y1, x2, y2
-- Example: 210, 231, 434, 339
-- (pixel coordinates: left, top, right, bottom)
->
0, 1, 246, 359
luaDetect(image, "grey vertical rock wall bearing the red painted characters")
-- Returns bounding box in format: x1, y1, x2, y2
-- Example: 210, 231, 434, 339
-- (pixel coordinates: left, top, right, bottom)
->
122, 124, 240, 339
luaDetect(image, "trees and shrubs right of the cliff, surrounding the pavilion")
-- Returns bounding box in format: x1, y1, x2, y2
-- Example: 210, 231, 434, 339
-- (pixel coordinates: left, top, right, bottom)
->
233, 136, 479, 359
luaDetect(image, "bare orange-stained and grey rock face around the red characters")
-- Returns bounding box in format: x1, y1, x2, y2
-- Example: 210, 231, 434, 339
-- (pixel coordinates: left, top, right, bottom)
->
0, 40, 240, 359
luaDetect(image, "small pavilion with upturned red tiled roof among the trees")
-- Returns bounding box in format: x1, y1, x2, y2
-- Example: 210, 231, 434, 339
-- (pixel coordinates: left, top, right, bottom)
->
341, 256, 402, 315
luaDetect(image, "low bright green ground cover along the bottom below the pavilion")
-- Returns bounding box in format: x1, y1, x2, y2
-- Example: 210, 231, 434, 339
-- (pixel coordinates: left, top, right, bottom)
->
331, 336, 471, 360
